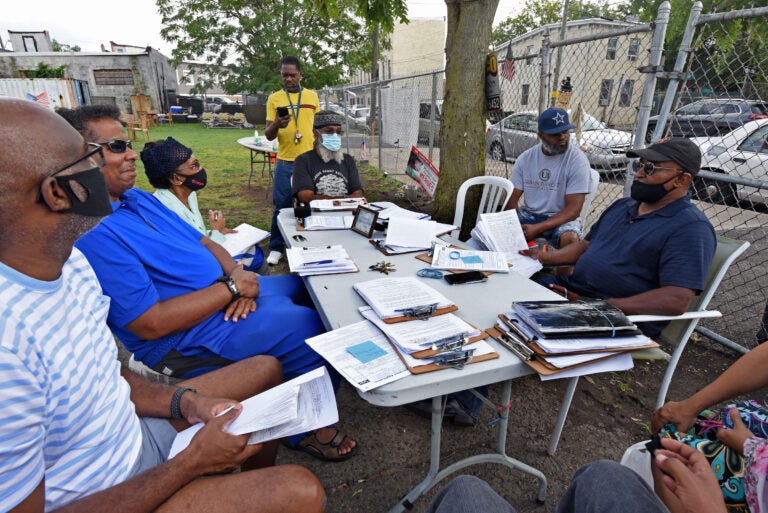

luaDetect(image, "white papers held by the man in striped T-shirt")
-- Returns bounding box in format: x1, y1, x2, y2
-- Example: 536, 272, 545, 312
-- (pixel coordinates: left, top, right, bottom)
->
168, 367, 339, 459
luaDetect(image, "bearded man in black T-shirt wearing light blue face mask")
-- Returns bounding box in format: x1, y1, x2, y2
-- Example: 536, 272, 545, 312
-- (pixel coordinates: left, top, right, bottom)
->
291, 110, 363, 203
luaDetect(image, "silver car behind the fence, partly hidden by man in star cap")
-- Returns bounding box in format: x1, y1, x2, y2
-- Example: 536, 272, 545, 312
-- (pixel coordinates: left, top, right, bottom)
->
485, 111, 632, 171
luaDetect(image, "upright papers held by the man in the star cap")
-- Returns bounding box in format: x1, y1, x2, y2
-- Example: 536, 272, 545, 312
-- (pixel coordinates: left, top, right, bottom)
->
470, 210, 542, 278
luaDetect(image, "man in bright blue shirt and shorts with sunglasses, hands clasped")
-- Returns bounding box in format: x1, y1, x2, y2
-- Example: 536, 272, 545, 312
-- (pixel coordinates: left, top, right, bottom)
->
63, 107, 355, 460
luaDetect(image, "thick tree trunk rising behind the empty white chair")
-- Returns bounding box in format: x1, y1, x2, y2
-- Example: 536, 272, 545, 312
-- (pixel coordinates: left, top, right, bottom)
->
432, 0, 499, 232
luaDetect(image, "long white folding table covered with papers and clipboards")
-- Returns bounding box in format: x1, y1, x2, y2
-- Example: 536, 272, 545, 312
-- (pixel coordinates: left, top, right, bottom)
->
278, 209, 562, 513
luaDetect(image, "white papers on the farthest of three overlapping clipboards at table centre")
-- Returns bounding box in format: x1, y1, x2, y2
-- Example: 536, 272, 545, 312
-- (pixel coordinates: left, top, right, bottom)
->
354, 277, 453, 319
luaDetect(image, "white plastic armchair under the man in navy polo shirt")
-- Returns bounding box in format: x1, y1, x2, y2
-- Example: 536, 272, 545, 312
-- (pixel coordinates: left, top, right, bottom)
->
547, 237, 749, 455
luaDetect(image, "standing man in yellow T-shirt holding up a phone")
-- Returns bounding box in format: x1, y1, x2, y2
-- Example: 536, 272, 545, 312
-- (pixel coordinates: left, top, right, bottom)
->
264, 56, 320, 265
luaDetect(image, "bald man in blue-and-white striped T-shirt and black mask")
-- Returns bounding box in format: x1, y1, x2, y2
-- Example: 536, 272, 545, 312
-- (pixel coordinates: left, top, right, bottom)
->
0, 98, 324, 513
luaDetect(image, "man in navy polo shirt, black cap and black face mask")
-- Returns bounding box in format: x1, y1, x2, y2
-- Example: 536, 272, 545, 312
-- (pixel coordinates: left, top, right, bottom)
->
521, 138, 717, 337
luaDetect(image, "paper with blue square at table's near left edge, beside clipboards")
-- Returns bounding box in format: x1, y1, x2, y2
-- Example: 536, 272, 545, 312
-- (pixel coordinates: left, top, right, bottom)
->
307, 321, 410, 392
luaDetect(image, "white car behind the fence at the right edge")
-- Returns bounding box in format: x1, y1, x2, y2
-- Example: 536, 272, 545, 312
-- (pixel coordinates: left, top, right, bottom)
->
693, 118, 768, 205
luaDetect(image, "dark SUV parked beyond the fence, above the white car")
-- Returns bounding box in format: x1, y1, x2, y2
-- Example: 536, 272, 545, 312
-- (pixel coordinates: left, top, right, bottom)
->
645, 98, 768, 142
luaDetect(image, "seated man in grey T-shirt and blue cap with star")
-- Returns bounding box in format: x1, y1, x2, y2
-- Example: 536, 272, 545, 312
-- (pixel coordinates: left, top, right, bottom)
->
506, 108, 591, 248
